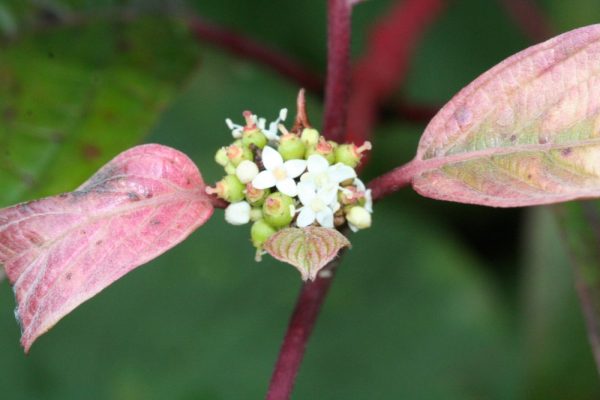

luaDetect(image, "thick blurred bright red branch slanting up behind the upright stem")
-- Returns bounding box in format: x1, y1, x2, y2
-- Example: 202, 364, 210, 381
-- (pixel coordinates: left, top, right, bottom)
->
347, 0, 445, 144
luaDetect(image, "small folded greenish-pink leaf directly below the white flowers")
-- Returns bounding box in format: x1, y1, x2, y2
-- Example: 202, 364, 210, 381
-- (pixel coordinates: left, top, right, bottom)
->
264, 226, 350, 281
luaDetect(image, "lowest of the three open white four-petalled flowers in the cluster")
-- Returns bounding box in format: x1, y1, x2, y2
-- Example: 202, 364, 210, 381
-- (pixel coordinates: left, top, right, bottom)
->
296, 182, 340, 228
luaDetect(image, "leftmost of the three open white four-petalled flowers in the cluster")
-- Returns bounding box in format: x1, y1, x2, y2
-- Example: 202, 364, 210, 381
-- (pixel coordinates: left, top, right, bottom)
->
252, 146, 306, 197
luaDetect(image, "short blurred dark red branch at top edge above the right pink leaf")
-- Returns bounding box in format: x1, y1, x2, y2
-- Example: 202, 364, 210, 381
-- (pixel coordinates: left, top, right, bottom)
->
500, 0, 553, 43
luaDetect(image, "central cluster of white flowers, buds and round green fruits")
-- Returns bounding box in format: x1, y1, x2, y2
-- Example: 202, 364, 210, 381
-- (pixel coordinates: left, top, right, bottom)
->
207, 109, 373, 255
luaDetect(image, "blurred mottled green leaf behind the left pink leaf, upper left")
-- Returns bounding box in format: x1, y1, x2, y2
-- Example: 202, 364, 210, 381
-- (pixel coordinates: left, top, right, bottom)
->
0, 17, 198, 206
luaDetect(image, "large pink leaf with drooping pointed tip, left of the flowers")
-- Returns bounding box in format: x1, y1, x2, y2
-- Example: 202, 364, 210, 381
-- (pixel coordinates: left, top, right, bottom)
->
0, 144, 213, 352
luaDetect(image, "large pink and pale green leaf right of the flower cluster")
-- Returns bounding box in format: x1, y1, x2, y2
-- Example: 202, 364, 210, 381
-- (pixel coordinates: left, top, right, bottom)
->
411, 25, 600, 207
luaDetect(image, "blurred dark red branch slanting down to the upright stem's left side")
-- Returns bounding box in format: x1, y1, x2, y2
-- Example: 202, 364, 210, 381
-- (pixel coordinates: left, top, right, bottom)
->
188, 17, 323, 93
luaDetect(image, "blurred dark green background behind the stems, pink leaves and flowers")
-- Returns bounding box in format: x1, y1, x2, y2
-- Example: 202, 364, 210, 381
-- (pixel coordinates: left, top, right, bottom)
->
0, 0, 600, 400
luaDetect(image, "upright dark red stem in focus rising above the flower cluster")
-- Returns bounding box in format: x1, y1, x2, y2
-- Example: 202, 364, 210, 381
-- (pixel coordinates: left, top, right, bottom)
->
323, 0, 352, 142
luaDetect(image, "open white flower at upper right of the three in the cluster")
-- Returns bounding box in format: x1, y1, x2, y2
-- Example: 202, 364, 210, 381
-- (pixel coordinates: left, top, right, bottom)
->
300, 154, 356, 196
